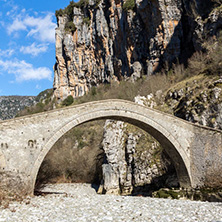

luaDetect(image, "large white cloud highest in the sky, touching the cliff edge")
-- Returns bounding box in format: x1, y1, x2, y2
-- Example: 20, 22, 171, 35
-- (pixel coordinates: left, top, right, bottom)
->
7, 13, 56, 43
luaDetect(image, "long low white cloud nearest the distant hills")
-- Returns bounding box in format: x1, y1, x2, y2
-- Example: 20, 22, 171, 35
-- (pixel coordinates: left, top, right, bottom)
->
0, 59, 52, 82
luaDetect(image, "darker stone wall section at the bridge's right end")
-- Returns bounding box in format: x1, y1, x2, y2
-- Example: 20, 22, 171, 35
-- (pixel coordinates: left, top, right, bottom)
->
190, 128, 222, 188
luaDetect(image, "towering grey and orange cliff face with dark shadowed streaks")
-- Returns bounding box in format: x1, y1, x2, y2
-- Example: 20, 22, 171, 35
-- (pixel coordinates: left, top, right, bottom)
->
54, 0, 222, 99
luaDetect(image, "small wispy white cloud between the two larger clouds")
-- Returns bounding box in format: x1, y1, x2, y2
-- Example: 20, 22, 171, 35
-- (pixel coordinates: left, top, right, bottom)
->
20, 42, 48, 56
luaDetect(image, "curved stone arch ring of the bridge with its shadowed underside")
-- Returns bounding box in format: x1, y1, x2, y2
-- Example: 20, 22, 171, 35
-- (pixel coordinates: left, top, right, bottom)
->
30, 108, 191, 192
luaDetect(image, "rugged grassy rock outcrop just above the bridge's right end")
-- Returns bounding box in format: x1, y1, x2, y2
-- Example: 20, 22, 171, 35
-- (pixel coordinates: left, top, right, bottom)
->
165, 75, 222, 129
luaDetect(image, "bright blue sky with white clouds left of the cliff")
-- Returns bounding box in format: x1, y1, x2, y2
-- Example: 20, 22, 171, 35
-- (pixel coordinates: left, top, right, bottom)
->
0, 0, 70, 96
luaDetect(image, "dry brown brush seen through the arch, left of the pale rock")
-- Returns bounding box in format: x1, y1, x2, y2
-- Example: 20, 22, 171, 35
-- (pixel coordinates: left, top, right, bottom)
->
36, 121, 104, 187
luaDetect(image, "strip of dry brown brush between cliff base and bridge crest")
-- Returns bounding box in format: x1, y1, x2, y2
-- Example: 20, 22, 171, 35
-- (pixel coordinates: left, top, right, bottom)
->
72, 71, 185, 105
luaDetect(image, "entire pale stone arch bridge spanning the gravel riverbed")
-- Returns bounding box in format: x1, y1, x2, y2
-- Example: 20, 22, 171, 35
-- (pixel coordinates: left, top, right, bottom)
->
0, 100, 222, 195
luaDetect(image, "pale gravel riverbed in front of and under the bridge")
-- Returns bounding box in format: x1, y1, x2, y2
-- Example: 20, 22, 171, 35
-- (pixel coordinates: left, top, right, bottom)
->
0, 184, 222, 222
